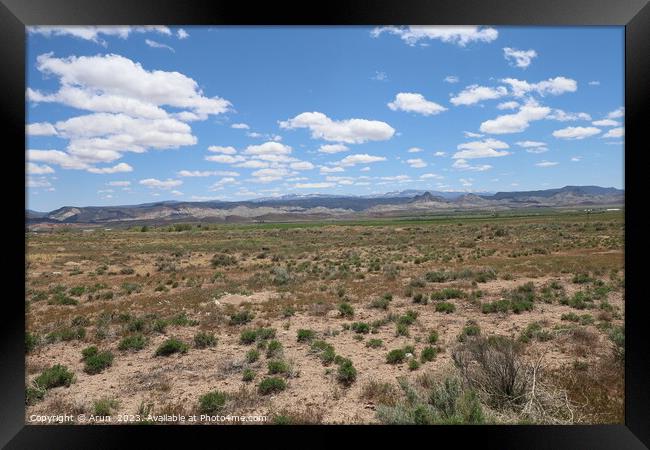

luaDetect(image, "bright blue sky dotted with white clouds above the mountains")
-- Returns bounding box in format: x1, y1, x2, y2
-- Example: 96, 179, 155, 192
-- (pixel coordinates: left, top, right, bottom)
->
26, 26, 624, 211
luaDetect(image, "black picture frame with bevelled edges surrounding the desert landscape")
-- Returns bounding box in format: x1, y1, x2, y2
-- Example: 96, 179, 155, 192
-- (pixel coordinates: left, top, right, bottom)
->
0, 0, 650, 449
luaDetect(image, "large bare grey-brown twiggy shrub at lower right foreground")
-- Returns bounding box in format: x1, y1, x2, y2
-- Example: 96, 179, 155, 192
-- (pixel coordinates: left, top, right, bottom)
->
452, 336, 528, 408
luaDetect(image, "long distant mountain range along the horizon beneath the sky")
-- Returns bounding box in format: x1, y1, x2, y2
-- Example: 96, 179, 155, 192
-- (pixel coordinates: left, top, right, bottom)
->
25, 186, 625, 225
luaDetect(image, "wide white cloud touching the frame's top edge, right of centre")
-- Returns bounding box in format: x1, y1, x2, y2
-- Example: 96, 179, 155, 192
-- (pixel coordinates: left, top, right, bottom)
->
371, 26, 499, 47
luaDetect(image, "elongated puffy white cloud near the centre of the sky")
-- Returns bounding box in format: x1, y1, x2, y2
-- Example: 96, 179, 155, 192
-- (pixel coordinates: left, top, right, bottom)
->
280, 112, 395, 144
